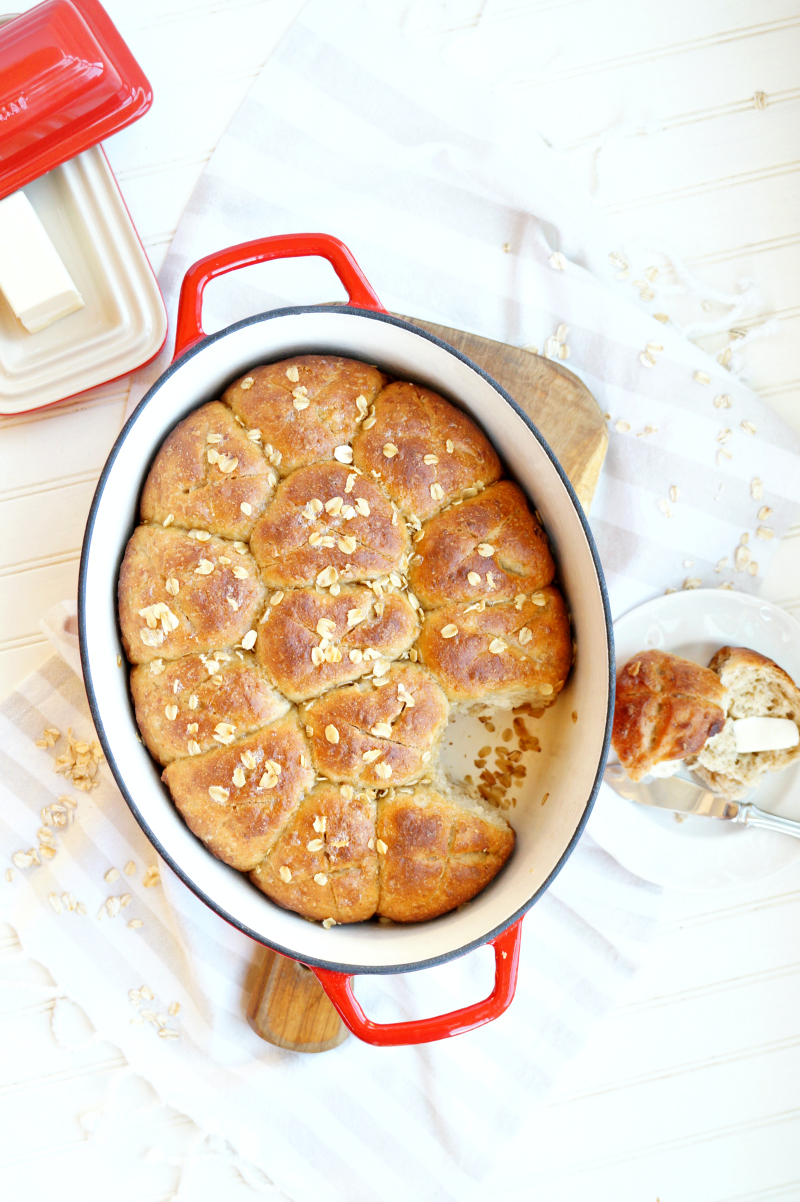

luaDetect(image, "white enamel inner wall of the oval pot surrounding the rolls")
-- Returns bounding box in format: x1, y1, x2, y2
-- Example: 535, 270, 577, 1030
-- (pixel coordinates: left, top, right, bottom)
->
79, 305, 614, 972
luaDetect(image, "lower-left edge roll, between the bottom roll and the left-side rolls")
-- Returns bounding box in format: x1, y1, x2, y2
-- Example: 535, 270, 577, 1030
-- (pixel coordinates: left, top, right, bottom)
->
162, 713, 314, 873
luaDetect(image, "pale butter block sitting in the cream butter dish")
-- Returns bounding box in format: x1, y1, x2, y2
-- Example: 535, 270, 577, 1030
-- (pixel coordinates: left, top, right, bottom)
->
0, 192, 83, 334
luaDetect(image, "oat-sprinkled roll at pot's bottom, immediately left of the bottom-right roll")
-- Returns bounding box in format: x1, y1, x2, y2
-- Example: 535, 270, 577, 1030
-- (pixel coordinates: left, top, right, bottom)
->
250, 784, 378, 926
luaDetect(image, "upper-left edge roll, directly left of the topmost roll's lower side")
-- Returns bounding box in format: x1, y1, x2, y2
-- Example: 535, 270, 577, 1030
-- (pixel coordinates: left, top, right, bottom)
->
136, 400, 277, 538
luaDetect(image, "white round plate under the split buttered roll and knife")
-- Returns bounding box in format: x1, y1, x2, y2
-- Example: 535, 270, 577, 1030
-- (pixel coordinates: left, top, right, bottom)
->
587, 589, 800, 892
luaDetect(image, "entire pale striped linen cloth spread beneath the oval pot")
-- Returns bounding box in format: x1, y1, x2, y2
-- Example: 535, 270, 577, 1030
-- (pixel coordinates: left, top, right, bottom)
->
0, 0, 800, 1202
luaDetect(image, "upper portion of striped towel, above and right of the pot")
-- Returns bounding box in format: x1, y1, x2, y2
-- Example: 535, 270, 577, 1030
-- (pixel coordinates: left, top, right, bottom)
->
129, 0, 800, 617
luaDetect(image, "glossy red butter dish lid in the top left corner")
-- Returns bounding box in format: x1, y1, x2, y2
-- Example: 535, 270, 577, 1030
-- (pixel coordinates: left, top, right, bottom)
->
0, 0, 153, 200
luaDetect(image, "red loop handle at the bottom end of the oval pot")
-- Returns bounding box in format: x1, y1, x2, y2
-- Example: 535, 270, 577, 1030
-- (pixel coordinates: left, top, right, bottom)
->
309, 918, 523, 1047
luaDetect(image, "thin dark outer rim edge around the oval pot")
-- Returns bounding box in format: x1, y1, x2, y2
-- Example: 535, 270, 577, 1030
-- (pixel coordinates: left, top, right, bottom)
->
78, 304, 615, 976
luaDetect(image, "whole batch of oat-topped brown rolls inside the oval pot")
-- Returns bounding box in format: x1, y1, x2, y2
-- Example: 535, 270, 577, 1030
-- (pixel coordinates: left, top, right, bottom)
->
119, 355, 573, 927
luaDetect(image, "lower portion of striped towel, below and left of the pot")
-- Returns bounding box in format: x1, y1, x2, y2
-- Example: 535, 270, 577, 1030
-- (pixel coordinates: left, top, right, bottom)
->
0, 605, 659, 1202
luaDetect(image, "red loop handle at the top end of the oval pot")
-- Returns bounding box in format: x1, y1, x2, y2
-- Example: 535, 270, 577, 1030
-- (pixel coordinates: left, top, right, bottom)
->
173, 233, 386, 361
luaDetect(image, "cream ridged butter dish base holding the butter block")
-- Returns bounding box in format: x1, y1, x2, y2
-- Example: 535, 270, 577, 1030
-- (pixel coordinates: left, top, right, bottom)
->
0, 145, 167, 413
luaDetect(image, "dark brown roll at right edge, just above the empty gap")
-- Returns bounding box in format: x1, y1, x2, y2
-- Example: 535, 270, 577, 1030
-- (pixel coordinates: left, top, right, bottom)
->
417, 587, 572, 709
